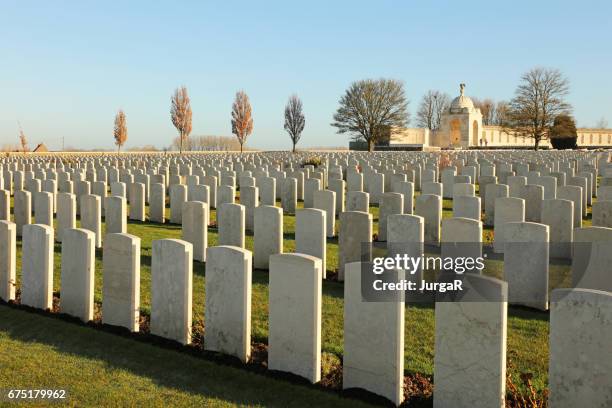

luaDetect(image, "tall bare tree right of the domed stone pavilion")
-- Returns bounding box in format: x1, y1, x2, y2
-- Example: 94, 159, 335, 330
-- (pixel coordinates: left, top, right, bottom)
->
507, 68, 571, 150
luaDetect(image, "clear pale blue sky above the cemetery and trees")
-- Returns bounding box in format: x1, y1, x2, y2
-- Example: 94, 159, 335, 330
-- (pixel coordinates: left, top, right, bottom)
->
0, 0, 612, 149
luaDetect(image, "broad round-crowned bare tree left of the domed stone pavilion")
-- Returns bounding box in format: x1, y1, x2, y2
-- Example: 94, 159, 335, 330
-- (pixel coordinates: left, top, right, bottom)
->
331, 79, 409, 151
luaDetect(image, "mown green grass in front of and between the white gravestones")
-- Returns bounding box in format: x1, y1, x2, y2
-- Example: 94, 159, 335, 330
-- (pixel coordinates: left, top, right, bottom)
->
0, 189, 587, 405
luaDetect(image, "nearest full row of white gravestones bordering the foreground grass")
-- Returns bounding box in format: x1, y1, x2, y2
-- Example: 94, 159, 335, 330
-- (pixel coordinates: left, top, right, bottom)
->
4, 214, 612, 406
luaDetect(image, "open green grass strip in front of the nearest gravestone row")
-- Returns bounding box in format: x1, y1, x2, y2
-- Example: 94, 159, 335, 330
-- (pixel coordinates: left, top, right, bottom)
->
0, 306, 366, 407
